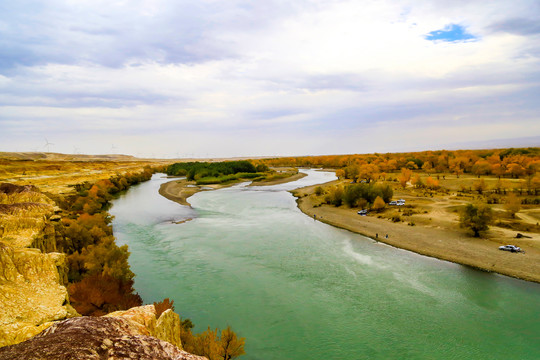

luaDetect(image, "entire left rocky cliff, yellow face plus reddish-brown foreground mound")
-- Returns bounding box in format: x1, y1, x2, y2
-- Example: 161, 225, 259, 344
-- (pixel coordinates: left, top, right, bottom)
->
0, 183, 206, 360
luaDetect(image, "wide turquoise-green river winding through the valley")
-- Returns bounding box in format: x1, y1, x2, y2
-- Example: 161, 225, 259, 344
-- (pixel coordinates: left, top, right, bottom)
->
110, 170, 540, 360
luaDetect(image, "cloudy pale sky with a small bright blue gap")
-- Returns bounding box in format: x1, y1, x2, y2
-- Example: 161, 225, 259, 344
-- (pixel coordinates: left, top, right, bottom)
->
0, 0, 540, 158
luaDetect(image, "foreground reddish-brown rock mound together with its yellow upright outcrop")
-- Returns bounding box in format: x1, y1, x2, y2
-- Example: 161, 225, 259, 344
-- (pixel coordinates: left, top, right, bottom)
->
0, 305, 206, 360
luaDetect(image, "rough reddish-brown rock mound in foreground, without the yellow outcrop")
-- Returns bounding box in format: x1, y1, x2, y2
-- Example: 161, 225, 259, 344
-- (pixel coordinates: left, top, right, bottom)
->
0, 316, 206, 360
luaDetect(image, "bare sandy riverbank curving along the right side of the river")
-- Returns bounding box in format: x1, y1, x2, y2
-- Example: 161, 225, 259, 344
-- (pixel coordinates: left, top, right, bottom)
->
293, 186, 540, 282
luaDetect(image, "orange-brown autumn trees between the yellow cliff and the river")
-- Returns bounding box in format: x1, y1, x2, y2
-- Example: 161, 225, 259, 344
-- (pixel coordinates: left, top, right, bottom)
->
46, 167, 155, 316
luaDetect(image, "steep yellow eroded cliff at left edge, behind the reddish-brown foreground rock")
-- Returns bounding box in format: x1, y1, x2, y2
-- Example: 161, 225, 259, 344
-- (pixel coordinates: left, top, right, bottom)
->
0, 184, 78, 347
